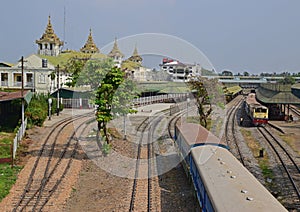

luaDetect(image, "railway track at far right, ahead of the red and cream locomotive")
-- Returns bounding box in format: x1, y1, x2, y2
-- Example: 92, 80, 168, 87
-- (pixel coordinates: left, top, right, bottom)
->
257, 127, 300, 210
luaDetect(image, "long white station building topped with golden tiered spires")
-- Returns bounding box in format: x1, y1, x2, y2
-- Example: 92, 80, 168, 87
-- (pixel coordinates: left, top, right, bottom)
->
0, 16, 155, 93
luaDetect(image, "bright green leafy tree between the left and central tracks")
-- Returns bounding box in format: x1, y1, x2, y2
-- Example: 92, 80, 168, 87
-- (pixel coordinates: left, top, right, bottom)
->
66, 58, 136, 147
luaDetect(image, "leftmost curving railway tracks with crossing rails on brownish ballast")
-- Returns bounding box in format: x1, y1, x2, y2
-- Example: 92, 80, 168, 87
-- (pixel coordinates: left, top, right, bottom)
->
13, 113, 92, 211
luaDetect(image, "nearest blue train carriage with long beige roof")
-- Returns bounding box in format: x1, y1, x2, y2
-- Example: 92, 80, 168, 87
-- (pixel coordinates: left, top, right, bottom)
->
190, 145, 287, 212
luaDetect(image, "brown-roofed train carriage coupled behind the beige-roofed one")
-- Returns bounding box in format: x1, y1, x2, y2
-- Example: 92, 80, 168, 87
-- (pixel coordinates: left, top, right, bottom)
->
175, 122, 228, 177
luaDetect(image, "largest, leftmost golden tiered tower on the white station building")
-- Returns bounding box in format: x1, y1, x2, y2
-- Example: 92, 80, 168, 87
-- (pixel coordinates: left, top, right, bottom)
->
35, 15, 63, 56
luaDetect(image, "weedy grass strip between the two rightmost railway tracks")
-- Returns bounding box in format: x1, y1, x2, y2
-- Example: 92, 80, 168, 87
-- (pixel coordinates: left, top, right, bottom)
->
241, 129, 274, 186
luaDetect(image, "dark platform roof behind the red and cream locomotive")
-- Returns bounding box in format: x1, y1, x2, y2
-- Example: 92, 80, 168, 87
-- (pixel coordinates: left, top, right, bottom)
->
256, 84, 300, 104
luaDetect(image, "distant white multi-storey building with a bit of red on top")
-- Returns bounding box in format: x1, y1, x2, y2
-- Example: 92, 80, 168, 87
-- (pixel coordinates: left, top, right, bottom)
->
160, 58, 201, 82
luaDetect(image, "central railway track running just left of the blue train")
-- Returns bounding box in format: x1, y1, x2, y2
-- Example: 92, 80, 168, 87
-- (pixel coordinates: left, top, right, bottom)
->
129, 106, 185, 211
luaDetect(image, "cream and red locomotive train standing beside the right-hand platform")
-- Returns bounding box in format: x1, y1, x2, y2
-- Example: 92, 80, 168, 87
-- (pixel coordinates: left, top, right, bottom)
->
244, 93, 269, 126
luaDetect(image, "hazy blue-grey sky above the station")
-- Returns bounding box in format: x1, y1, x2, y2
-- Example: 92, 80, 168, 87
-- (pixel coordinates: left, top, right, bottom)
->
0, 0, 300, 74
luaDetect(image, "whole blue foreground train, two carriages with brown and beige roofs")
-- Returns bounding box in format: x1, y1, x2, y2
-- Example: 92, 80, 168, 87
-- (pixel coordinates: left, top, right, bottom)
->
174, 123, 287, 212
